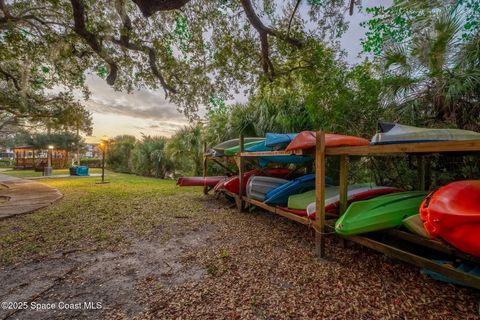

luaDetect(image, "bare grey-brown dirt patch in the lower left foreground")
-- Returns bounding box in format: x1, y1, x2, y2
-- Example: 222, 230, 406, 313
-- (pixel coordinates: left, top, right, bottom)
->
0, 225, 215, 319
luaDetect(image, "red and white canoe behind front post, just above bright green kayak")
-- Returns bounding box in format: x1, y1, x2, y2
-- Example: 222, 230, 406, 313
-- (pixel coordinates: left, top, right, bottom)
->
307, 184, 402, 218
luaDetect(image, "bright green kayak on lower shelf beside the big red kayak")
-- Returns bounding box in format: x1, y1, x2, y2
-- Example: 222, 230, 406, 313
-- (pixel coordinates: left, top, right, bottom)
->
335, 191, 428, 235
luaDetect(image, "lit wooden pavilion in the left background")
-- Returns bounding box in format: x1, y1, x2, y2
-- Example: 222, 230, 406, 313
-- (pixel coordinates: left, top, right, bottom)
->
13, 146, 69, 170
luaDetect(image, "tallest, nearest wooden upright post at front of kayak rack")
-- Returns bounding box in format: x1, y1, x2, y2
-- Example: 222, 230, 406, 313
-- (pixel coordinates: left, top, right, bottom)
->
315, 131, 325, 258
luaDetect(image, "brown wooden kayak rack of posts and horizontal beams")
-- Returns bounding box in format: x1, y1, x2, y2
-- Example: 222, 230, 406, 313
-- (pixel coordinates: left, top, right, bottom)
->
222, 131, 480, 289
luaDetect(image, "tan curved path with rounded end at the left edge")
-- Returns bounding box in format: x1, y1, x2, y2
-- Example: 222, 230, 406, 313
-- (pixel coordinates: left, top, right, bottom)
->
0, 173, 62, 219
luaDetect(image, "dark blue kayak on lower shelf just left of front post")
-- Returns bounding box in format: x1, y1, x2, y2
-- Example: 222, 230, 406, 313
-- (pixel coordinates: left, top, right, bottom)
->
265, 174, 315, 206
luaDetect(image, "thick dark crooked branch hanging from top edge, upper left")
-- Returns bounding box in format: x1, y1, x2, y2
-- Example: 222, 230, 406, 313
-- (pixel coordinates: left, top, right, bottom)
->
70, 0, 118, 85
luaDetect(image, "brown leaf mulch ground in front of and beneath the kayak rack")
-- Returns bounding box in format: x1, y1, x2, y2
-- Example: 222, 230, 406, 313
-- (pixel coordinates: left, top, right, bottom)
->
118, 198, 480, 319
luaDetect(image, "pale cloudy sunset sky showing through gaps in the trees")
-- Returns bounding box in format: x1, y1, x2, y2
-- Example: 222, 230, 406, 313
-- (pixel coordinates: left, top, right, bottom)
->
84, 0, 382, 143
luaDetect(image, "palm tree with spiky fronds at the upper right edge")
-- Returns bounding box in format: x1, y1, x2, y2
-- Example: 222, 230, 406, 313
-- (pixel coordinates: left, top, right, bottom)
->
382, 9, 480, 130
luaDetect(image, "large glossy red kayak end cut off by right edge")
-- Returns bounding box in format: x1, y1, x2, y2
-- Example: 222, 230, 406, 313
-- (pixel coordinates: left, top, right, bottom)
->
420, 180, 480, 256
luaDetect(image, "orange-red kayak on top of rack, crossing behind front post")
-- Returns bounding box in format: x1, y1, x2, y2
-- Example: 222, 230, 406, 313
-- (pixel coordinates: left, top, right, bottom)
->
285, 131, 370, 151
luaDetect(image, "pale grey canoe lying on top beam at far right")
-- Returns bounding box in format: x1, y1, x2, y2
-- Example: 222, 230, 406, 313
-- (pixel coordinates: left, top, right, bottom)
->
371, 123, 480, 144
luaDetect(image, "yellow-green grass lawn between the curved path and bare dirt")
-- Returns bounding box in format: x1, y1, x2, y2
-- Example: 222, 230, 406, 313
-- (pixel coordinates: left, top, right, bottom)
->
0, 171, 200, 264
